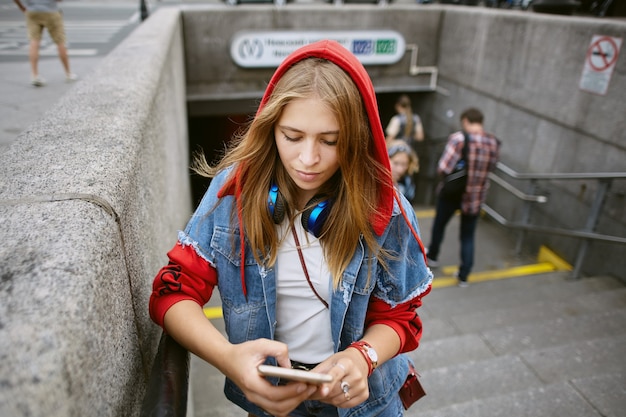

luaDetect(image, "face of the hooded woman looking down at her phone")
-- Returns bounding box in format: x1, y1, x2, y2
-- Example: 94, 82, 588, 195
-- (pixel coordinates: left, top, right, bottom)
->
274, 97, 339, 208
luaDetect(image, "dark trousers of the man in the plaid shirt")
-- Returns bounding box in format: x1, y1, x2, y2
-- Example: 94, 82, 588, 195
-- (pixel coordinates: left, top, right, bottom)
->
428, 194, 478, 281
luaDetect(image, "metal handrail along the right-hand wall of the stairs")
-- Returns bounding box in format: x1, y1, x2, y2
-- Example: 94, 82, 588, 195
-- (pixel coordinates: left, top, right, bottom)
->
482, 162, 626, 278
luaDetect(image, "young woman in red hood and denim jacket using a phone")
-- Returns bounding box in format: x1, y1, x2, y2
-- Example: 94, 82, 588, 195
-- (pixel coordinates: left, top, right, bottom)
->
150, 41, 432, 417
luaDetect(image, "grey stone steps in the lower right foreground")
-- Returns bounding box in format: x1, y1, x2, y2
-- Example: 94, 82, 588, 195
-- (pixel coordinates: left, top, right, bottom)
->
406, 272, 626, 417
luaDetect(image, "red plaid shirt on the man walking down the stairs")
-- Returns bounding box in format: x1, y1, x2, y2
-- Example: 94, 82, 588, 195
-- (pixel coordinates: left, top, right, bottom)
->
437, 132, 500, 214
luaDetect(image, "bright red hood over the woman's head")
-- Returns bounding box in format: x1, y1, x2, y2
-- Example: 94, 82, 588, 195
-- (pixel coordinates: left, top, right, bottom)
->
219, 40, 394, 235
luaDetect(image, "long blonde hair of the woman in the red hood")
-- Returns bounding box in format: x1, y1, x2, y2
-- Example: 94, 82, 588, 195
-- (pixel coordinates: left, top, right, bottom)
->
196, 58, 389, 288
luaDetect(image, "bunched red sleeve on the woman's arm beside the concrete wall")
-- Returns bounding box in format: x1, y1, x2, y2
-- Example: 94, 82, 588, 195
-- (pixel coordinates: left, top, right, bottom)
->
149, 242, 217, 327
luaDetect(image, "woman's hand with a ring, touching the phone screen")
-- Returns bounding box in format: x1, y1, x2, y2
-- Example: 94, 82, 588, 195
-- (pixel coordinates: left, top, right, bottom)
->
311, 349, 369, 408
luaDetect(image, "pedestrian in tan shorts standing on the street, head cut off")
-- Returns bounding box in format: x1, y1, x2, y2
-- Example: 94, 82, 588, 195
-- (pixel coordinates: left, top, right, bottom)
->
13, 0, 78, 87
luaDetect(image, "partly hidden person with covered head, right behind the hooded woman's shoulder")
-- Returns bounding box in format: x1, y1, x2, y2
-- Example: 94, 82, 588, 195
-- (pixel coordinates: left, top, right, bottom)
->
388, 140, 419, 202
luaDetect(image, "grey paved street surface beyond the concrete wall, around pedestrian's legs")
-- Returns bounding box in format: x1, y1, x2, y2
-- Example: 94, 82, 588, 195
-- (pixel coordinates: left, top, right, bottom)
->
0, 0, 139, 155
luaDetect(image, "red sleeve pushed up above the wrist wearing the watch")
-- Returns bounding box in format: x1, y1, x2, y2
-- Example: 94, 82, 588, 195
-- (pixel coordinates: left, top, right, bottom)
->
365, 286, 432, 353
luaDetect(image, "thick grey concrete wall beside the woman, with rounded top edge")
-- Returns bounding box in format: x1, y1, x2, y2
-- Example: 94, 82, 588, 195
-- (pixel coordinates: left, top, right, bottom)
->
0, 9, 191, 417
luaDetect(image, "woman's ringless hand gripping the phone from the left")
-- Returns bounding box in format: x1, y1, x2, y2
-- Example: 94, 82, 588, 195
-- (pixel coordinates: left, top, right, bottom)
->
220, 339, 316, 417
